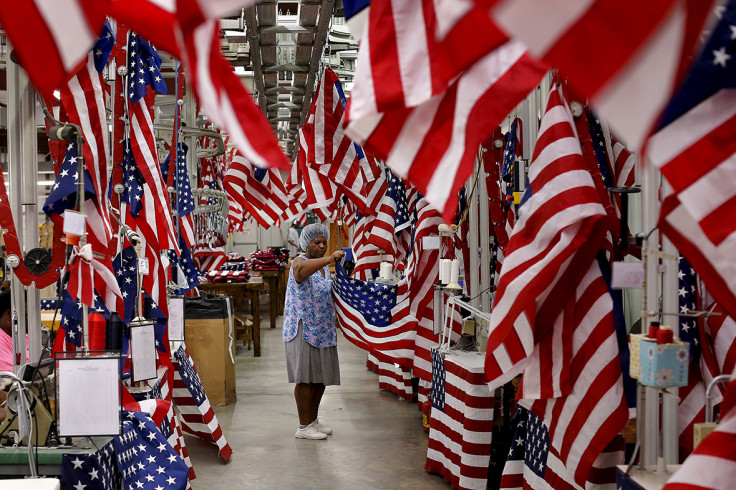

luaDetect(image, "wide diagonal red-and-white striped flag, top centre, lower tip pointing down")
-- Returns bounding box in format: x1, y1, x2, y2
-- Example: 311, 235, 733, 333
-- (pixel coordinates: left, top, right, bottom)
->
346, 37, 545, 222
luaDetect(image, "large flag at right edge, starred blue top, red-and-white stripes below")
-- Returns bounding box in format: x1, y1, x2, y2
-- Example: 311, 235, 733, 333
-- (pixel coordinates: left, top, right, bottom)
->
646, 1, 736, 326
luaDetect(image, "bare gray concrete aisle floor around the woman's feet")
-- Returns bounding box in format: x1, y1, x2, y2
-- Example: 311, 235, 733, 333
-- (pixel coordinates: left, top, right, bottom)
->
186, 301, 448, 490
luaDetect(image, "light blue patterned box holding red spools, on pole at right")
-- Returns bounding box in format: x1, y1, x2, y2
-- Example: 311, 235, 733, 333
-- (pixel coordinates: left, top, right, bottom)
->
639, 338, 690, 387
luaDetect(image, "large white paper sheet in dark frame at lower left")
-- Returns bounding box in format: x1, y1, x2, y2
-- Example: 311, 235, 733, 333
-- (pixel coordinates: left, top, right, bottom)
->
56, 357, 120, 436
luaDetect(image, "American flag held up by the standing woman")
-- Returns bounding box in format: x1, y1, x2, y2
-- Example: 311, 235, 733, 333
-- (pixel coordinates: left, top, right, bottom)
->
332, 264, 416, 366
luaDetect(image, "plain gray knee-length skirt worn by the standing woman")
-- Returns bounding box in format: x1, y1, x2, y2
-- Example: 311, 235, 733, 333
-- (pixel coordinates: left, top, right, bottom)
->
284, 321, 340, 386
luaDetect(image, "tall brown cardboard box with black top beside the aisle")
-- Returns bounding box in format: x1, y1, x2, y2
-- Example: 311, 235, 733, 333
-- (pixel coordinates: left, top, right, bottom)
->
184, 298, 237, 405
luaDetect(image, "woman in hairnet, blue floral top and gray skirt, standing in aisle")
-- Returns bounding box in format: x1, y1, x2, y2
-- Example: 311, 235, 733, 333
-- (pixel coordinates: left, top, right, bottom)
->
283, 223, 345, 439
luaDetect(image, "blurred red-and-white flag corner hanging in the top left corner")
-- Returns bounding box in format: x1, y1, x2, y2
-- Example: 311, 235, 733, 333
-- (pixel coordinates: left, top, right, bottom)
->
0, 0, 107, 98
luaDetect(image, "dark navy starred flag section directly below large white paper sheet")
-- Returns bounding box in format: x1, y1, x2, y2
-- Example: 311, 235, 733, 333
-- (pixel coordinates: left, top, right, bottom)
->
61, 441, 123, 490
